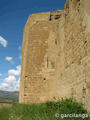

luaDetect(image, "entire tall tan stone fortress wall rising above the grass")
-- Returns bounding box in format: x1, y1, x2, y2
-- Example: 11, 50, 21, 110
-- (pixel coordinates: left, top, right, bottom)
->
19, 0, 90, 110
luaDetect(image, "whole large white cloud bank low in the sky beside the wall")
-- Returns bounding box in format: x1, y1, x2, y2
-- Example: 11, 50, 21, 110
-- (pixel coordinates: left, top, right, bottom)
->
0, 65, 21, 91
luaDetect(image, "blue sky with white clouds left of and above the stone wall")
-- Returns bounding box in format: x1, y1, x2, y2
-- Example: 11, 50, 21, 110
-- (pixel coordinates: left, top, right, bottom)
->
0, 0, 66, 91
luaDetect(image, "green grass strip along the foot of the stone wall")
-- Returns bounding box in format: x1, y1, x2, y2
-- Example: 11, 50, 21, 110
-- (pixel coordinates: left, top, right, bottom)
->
0, 99, 90, 120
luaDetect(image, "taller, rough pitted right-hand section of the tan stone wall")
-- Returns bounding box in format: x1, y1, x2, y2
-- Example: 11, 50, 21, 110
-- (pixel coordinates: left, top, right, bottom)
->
57, 0, 90, 110
